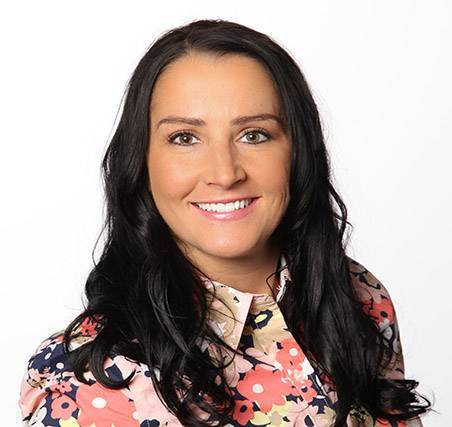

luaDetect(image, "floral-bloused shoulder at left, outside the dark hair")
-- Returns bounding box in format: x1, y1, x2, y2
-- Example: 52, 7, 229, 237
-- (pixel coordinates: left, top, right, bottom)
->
19, 319, 185, 427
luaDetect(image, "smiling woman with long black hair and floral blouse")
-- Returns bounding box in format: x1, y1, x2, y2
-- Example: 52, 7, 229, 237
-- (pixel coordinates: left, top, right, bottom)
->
20, 20, 430, 427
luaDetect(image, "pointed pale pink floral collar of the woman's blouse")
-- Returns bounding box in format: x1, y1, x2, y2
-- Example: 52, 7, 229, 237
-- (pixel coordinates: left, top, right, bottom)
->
197, 255, 290, 351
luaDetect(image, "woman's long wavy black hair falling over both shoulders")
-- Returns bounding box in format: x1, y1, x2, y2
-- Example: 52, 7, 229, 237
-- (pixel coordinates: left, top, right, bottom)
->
64, 20, 430, 427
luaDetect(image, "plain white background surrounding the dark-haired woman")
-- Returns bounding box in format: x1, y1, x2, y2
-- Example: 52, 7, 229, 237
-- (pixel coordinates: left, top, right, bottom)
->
0, 0, 452, 427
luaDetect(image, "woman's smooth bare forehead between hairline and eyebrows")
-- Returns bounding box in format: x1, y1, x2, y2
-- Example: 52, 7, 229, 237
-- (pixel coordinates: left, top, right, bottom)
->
150, 53, 280, 117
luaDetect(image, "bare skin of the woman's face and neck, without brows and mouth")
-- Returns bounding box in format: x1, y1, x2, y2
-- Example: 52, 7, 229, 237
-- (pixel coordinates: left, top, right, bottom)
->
147, 53, 291, 294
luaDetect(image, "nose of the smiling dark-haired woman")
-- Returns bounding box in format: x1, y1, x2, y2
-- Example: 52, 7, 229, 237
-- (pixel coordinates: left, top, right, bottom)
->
204, 141, 246, 188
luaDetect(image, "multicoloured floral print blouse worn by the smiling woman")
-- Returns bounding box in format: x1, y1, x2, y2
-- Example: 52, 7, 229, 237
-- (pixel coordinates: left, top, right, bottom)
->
19, 255, 422, 427
